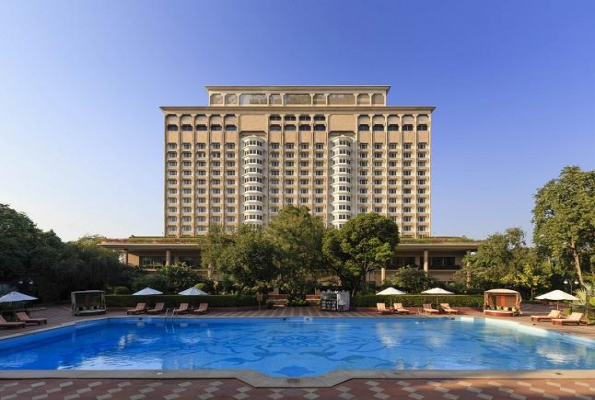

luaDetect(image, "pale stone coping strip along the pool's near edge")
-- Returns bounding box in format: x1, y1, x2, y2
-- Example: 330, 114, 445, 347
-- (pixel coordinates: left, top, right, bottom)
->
0, 370, 593, 388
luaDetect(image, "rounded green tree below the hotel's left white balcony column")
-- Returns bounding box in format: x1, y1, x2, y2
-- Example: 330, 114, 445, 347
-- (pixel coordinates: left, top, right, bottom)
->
221, 225, 278, 291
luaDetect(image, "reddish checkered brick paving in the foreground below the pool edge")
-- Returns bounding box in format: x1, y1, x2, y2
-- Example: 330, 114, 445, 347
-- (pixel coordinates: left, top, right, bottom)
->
0, 378, 595, 400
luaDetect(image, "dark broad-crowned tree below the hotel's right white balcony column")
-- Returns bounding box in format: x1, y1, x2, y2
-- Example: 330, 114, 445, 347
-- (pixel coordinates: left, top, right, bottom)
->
324, 213, 399, 294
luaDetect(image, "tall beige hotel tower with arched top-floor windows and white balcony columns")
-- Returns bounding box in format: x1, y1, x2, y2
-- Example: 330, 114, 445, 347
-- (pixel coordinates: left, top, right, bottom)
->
162, 86, 434, 237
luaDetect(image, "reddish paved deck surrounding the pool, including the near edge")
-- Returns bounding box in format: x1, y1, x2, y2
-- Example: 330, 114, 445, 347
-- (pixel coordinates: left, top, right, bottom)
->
0, 305, 595, 400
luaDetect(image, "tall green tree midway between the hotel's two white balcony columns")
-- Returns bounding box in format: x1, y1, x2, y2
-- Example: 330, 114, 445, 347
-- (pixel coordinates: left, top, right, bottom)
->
265, 205, 326, 300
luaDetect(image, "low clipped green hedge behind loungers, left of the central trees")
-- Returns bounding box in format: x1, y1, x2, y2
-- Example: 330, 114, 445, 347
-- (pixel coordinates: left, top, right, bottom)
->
105, 295, 258, 307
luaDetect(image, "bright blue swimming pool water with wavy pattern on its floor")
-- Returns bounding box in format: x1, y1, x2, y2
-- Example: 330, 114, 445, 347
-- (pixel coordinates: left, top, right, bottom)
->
0, 317, 595, 377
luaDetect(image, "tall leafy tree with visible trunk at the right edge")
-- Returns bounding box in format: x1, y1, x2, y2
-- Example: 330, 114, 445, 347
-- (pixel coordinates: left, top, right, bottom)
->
533, 166, 595, 285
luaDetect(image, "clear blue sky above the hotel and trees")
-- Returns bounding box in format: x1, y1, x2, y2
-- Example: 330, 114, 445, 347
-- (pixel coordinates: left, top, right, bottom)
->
0, 0, 595, 240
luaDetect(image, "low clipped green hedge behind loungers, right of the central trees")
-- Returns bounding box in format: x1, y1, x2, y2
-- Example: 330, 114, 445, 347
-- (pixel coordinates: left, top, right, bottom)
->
352, 294, 483, 307
